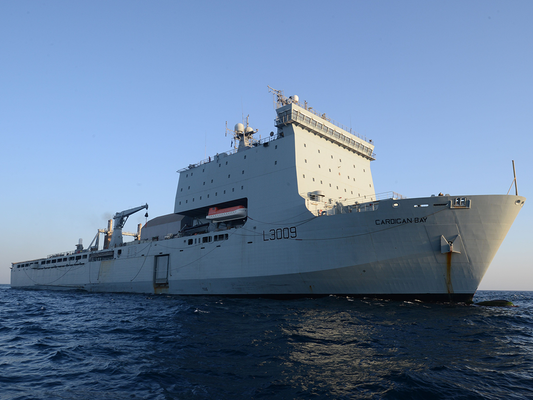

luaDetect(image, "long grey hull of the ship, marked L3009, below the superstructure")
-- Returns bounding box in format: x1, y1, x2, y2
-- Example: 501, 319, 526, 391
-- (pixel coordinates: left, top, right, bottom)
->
11, 195, 525, 301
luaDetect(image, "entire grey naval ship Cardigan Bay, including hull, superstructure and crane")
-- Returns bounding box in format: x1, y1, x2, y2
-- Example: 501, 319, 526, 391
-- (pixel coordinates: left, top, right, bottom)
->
11, 87, 526, 302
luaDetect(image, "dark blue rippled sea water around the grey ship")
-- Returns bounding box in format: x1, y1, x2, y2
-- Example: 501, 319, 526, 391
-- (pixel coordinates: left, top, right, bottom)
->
0, 286, 533, 400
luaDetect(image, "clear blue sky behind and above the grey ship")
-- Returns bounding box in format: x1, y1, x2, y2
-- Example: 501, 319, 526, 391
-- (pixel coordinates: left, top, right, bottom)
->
0, 0, 533, 290
